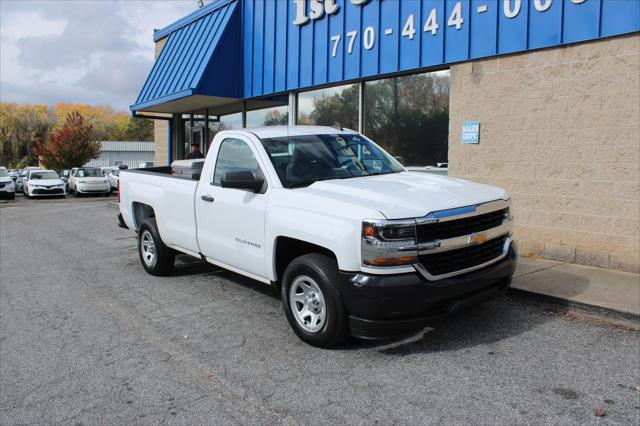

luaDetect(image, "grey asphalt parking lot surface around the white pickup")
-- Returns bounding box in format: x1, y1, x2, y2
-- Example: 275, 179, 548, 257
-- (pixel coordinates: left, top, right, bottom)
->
0, 197, 640, 424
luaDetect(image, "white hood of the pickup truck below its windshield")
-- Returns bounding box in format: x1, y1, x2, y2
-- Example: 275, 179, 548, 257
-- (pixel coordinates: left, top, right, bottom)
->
295, 172, 509, 219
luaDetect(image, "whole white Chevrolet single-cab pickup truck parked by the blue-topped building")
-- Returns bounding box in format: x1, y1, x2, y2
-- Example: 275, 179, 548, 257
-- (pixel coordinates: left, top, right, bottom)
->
118, 126, 517, 347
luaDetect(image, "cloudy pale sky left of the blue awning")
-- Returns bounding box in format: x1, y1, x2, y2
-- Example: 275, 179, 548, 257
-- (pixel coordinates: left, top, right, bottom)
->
0, 0, 202, 111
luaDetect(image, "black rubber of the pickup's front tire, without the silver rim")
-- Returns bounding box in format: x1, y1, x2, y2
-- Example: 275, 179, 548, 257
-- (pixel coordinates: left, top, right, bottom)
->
280, 253, 349, 348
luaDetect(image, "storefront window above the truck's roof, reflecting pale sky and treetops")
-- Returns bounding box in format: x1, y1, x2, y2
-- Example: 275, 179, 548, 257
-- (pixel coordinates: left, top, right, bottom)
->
298, 84, 358, 130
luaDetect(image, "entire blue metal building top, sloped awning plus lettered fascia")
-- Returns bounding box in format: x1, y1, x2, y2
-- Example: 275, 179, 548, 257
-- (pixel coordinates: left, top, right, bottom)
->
139, 0, 640, 111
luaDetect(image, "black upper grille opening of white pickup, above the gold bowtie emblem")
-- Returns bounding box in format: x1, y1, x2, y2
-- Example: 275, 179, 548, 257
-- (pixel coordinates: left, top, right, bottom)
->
416, 209, 507, 243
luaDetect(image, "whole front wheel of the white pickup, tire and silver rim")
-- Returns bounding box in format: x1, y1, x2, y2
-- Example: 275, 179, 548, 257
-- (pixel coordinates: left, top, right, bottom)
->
281, 253, 349, 348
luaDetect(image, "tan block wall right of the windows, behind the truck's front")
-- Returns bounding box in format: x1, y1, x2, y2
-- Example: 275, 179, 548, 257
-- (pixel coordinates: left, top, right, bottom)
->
449, 34, 640, 272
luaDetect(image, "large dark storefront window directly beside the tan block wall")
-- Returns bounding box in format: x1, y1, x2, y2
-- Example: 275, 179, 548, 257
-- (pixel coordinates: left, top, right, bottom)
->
364, 71, 449, 166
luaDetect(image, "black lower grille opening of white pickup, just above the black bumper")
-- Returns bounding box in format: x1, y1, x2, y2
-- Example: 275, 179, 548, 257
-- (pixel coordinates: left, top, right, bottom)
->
418, 237, 505, 275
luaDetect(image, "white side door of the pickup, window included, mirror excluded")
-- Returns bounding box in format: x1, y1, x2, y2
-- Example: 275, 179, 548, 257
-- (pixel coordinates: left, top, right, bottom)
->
195, 136, 268, 279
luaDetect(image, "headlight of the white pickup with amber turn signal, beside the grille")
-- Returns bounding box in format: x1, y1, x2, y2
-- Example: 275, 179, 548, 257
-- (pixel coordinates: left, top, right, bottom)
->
361, 220, 418, 267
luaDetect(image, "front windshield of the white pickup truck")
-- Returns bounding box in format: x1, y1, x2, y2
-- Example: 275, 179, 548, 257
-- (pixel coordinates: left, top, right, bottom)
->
262, 134, 402, 188
